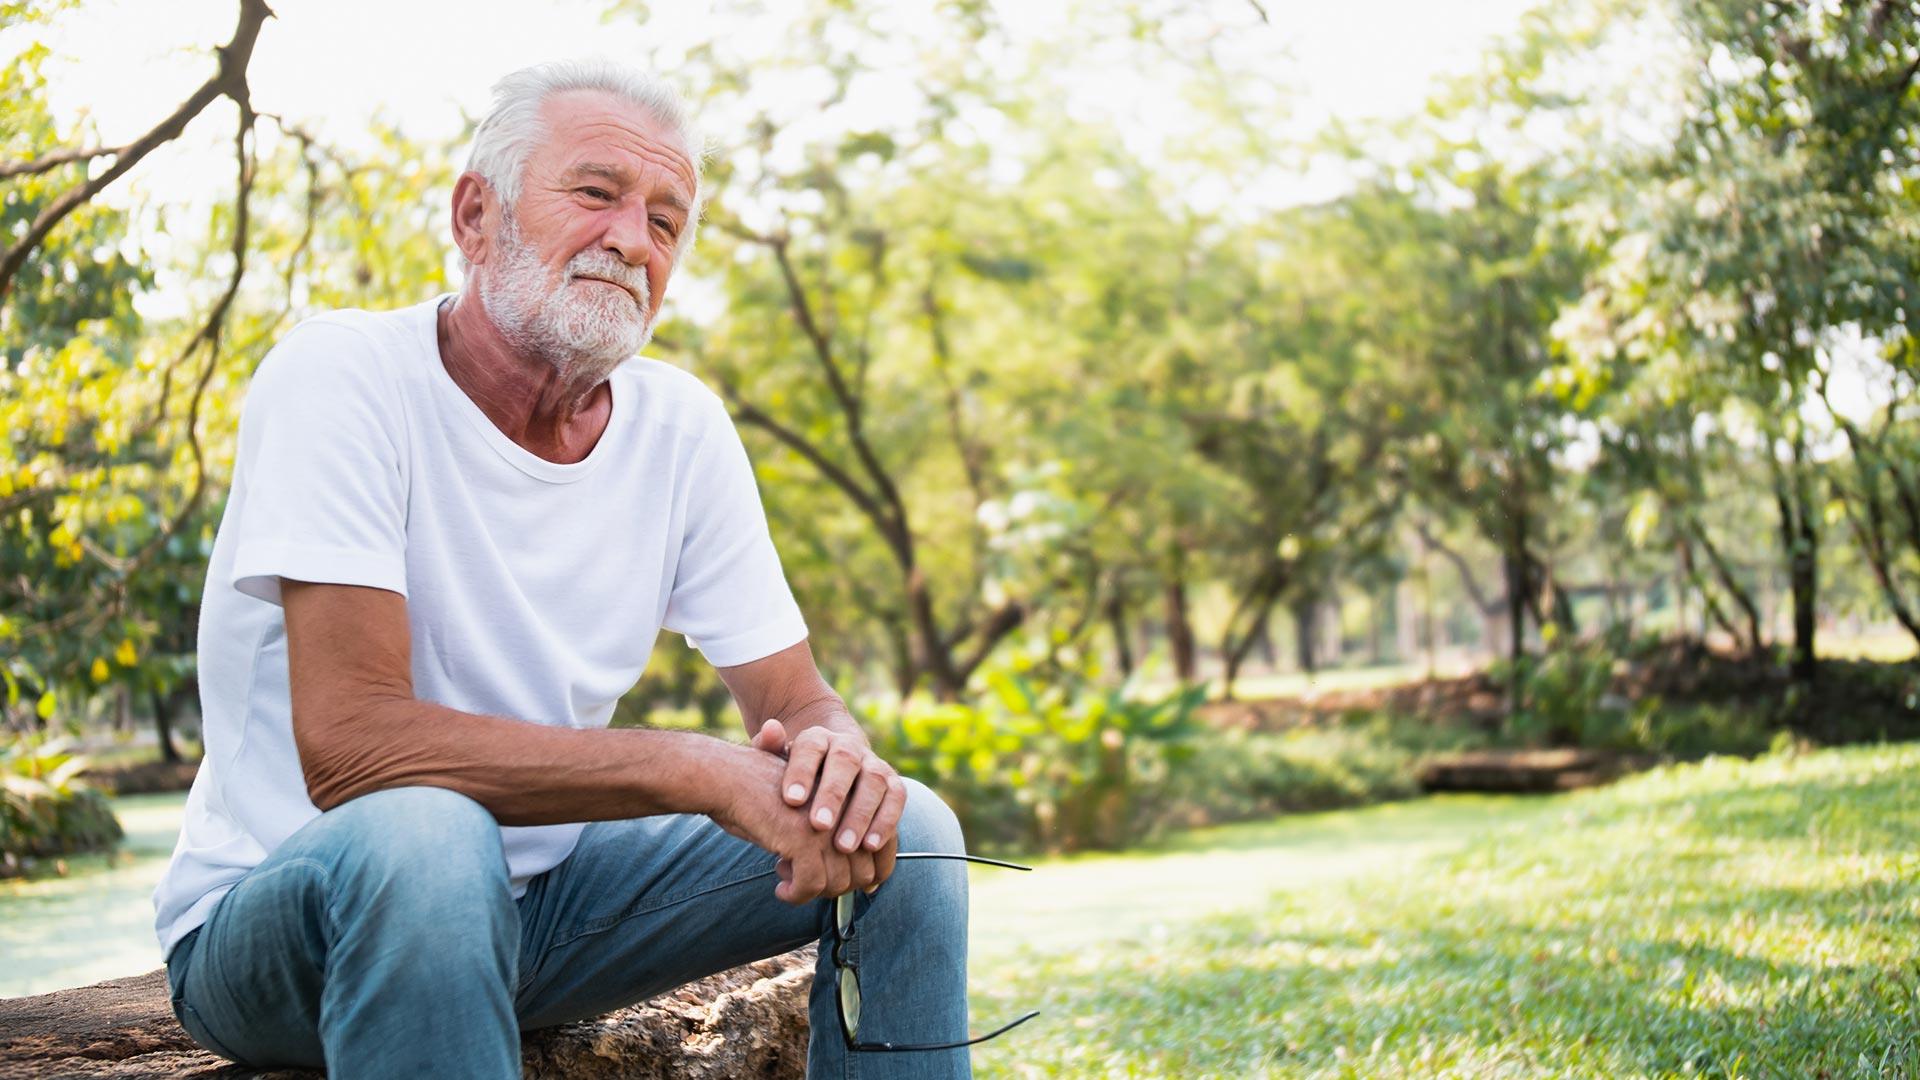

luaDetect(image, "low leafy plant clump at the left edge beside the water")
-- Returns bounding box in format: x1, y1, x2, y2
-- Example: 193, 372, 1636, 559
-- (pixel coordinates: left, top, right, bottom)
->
0, 738, 123, 876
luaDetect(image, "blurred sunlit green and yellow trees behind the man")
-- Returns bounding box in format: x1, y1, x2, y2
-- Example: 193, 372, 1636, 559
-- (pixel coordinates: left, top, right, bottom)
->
0, 0, 1920, 849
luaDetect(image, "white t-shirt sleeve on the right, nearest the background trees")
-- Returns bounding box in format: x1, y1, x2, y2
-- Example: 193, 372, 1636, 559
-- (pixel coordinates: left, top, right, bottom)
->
662, 400, 806, 667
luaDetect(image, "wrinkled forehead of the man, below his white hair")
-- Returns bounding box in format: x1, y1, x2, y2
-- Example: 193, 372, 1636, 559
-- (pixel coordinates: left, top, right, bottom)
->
528, 90, 699, 206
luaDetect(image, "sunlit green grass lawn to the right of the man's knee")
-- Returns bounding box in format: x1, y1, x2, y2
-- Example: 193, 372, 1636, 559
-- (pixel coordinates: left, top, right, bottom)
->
973, 746, 1920, 1076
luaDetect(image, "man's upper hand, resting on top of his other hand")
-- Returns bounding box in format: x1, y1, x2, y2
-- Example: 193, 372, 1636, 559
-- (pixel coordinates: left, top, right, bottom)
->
753, 721, 906, 892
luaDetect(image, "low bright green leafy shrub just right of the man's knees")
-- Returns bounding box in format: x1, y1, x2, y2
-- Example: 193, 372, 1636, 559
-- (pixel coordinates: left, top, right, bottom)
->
868, 638, 1417, 851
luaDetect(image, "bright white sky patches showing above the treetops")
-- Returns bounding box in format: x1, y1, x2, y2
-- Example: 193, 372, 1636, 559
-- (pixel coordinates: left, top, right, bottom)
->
22, 0, 1532, 210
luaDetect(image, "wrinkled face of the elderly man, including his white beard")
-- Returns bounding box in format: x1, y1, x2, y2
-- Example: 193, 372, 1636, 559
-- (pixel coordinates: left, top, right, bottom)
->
480, 90, 693, 373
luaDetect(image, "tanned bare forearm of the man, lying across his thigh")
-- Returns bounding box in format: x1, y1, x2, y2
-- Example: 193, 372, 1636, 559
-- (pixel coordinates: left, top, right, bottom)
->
294, 698, 756, 824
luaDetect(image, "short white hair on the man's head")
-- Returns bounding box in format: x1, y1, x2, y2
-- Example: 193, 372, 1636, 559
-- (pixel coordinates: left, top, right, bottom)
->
467, 60, 707, 265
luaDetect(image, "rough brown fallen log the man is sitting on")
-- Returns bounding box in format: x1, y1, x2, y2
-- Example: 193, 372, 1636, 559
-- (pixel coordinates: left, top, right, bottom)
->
0, 947, 814, 1080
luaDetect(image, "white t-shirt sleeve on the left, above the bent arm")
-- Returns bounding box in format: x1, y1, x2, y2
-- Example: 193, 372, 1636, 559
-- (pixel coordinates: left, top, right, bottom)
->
223, 323, 407, 603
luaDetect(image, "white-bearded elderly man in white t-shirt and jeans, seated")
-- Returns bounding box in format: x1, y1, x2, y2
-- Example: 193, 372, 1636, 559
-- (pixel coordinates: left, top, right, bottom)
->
156, 63, 990, 1078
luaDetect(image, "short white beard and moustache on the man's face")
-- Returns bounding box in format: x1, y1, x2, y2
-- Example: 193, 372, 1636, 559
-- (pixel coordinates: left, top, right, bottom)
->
480, 213, 653, 384
